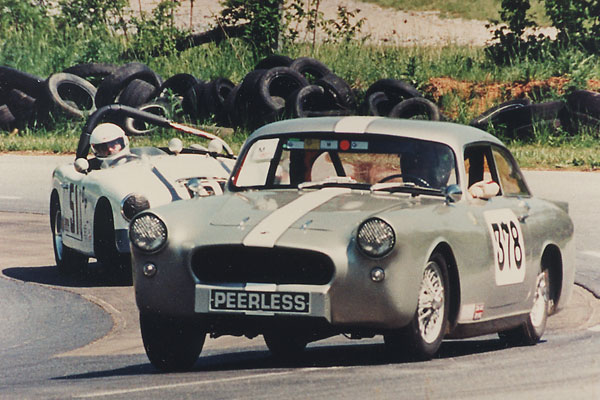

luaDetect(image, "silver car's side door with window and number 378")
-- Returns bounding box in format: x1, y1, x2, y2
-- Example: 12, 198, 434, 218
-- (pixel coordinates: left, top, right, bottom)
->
465, 144, 531, 316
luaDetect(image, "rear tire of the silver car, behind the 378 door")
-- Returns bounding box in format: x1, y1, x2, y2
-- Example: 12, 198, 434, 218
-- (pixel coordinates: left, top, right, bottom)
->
498, 271, 549, 346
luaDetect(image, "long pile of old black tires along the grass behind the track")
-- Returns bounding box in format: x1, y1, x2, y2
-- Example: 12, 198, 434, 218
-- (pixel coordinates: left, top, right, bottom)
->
0, 55, 600, 138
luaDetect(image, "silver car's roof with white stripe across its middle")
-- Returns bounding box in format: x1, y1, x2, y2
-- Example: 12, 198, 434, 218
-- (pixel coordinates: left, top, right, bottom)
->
247, 116, 505, 151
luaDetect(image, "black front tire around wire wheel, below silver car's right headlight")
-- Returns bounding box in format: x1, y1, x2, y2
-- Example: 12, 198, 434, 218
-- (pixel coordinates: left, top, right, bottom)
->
384, 254, 450, 361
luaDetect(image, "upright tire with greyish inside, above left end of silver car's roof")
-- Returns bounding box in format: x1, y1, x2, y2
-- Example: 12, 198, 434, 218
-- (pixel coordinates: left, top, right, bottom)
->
256, 67, 308, 115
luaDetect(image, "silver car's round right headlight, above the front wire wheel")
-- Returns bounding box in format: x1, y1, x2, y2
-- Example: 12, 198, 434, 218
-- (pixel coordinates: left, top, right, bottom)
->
356, 218, 396, 257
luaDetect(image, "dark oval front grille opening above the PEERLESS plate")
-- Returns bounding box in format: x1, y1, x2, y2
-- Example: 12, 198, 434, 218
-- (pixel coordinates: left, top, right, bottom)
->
192, 246, 334, 285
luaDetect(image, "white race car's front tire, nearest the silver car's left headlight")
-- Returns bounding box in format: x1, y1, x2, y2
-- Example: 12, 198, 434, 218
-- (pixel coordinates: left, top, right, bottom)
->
94, 198, 131, 275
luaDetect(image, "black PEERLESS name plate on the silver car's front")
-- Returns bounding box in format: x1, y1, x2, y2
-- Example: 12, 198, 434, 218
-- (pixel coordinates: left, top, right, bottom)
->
210, 289, 310, 314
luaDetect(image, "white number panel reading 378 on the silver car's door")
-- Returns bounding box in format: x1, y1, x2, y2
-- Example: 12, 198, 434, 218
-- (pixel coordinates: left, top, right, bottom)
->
484, 209, 526, 286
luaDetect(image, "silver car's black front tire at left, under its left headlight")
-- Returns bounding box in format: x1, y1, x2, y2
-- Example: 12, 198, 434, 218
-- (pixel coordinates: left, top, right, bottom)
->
140, 313, 206, 372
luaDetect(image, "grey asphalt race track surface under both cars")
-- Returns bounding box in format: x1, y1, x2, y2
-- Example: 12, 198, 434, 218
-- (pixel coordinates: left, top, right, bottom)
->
0, 156, 600, 399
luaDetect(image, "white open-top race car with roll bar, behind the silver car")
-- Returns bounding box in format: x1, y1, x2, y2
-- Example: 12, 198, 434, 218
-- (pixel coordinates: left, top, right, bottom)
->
50, 105, 235, 275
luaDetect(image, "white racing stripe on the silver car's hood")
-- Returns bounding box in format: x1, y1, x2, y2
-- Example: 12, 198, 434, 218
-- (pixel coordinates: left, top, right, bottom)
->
243, 188, 350, 247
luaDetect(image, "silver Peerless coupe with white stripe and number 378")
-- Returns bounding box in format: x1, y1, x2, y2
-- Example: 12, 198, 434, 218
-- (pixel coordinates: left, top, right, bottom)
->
129, 117, 575, 370
